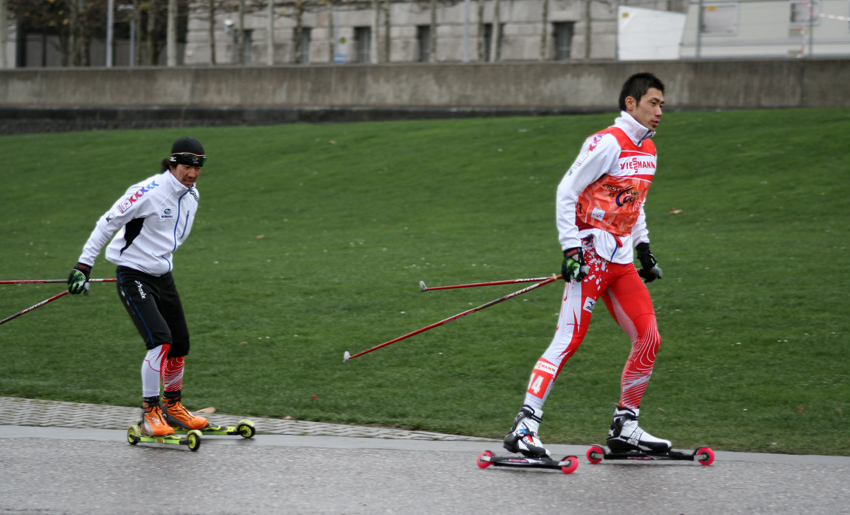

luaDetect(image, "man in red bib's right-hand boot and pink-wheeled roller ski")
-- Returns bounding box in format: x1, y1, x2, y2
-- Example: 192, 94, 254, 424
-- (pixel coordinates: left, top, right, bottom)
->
587, 407, 714, 465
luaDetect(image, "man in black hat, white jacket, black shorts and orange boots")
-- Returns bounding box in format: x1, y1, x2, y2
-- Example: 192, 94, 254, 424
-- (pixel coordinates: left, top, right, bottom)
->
68, 137, 208, 436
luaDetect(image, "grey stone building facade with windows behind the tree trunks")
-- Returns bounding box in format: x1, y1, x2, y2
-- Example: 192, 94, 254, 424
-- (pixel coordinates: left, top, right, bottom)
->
185, 0, 685, 65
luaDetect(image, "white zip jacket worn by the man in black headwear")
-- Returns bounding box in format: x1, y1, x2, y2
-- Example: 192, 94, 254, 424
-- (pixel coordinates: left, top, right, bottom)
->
79, 171, 199, 276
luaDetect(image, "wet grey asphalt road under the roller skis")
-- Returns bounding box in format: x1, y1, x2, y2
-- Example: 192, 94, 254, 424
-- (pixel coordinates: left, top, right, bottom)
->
0, 426, 850, 515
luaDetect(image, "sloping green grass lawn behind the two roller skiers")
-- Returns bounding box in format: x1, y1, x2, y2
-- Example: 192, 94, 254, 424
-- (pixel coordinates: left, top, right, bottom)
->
0, 109, 850, 455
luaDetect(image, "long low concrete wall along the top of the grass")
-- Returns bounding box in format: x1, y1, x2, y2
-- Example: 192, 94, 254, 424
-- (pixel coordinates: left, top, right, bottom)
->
0, 59, 850, 131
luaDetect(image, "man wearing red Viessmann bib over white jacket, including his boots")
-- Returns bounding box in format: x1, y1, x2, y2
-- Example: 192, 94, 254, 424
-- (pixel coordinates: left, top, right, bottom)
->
504, 73, 671, 457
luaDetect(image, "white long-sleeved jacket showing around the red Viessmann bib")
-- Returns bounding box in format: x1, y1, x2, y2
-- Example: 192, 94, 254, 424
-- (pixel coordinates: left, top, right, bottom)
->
556, 111, 655, 264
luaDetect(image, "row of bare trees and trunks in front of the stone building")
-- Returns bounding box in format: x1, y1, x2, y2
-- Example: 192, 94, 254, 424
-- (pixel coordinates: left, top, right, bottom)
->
0, 0, 556, 66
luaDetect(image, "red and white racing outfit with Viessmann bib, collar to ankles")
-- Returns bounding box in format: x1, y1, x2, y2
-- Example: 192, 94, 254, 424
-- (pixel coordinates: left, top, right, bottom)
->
525, 112, 661, 408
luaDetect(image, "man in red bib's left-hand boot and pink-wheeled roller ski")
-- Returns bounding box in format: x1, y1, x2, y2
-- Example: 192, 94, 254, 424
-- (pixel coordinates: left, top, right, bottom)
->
478, 405, 578, 474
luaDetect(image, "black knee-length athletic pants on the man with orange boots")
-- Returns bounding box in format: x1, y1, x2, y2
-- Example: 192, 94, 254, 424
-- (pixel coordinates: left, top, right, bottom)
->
116, 266, 189, 358
